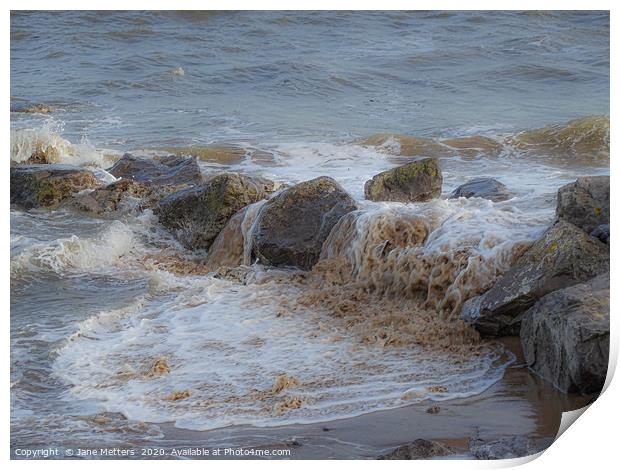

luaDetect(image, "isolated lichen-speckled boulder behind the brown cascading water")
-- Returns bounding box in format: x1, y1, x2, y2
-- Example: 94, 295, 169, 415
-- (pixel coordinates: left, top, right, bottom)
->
364, 158, 443, 202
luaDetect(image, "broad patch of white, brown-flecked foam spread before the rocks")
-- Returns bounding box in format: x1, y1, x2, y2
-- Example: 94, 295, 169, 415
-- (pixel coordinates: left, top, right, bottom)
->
54, 277, 512, 429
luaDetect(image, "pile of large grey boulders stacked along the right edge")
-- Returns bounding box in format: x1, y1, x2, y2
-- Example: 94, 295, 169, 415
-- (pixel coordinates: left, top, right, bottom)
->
461, 176, 610, 394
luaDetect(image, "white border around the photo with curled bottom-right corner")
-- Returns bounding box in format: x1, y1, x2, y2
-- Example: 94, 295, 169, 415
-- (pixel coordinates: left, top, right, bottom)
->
0, 0, 620, 470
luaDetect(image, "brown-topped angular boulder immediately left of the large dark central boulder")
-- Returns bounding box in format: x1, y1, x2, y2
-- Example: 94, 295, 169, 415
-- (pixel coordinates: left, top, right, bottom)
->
155, 173, 267, 249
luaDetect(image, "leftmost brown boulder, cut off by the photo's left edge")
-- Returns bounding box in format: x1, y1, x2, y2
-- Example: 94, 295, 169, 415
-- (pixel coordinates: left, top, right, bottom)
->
11, 164, 100, 209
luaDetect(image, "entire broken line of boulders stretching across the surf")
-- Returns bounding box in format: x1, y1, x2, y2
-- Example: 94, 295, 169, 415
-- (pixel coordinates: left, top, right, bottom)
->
11, 149, 610, 393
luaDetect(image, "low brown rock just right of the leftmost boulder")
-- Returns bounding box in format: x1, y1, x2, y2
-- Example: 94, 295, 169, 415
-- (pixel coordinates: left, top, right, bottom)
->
67, 179, 152, 214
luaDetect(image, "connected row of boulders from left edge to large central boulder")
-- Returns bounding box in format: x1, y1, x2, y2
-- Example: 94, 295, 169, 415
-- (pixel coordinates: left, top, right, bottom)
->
11, 154, 357, 269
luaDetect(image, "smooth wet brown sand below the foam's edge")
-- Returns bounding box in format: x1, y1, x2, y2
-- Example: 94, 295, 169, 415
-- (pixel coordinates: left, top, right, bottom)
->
154, 338, 592, 459
